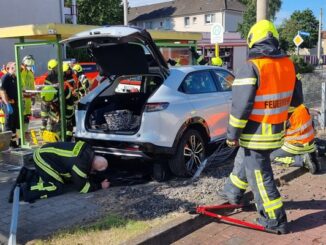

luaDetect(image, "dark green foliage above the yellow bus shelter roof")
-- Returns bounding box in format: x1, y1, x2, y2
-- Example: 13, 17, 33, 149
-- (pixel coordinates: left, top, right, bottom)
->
77, 0, 123, 25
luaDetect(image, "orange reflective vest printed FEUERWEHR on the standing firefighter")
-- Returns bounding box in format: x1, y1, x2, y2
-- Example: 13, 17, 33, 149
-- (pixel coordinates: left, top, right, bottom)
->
249, 57, 296, 124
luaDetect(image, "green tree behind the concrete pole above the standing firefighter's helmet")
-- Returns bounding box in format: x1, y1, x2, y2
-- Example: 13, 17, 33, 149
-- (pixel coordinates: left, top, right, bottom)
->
238, 0, 282, 38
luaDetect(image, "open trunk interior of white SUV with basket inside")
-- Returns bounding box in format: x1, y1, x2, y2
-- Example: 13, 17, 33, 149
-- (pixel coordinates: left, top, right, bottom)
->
85, 75, 163, 134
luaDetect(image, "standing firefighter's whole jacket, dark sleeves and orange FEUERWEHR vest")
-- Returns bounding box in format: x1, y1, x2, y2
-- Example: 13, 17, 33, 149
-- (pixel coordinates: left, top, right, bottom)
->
227, 56, 302, 150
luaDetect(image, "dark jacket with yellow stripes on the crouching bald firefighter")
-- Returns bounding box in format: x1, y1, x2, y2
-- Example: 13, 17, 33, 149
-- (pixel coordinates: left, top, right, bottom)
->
33, 141, 100, 193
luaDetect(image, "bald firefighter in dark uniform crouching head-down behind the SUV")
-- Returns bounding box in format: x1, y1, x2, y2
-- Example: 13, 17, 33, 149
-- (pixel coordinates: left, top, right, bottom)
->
9, 141, 110, 202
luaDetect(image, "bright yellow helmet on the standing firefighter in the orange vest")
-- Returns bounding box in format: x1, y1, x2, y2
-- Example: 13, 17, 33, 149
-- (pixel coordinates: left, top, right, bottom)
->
247, 20, 279, 48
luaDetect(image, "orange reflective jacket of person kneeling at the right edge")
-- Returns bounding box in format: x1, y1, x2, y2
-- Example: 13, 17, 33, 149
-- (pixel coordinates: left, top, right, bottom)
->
282, 104, 315, 154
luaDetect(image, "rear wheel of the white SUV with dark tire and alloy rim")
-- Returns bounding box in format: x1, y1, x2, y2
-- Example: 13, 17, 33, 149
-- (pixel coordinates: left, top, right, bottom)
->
169, 129, 207, 177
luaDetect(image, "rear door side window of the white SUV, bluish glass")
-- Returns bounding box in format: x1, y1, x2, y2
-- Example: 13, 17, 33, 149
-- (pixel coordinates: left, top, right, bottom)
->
179, 71, 217, 94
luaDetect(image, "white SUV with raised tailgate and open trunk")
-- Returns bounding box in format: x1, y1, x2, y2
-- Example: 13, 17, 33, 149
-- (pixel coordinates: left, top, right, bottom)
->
64, 26, 234, 176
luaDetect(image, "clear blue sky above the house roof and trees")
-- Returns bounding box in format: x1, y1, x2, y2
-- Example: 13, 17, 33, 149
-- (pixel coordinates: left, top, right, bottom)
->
129, 0, 326, 30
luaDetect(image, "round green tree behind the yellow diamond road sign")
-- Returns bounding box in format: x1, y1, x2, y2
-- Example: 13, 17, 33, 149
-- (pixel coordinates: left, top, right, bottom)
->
279, 9, 319, 51
